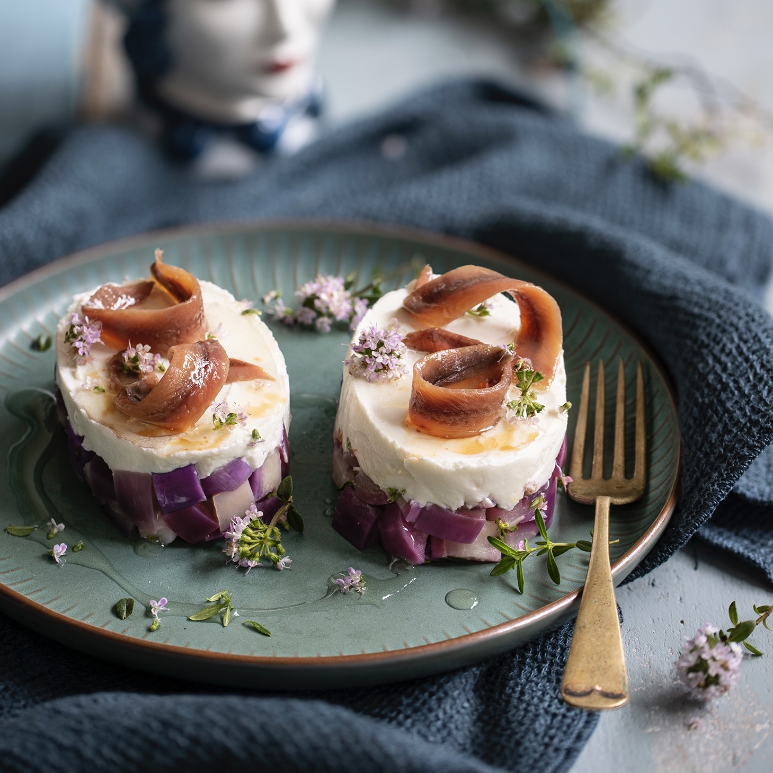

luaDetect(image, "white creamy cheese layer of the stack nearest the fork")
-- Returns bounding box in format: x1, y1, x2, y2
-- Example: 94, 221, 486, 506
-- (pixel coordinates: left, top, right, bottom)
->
336, 288, 567, 510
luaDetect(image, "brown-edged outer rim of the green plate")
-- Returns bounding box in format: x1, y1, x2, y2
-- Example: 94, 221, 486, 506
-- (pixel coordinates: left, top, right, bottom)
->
0, 218, 682, 683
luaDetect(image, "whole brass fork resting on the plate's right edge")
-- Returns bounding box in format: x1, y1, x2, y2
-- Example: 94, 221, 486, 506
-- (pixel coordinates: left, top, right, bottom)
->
561, 360, 646, 709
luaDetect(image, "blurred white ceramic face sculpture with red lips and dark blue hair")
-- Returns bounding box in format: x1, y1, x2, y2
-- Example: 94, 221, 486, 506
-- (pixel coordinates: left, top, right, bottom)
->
125, 0, 335, 158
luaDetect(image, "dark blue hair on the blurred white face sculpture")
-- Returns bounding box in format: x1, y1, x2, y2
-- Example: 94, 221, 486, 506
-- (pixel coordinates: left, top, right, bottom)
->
123, 0, 172, 101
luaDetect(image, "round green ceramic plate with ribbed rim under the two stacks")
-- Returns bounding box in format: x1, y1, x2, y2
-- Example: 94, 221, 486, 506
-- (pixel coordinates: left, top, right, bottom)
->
0, 223, 679, 688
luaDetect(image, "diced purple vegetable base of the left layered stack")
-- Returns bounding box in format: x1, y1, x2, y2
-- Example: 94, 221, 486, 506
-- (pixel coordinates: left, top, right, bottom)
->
66, 414, 290, 544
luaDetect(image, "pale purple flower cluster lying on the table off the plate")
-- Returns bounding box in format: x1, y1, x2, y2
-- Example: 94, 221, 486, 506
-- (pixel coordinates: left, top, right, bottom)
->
676, 624, 743, 701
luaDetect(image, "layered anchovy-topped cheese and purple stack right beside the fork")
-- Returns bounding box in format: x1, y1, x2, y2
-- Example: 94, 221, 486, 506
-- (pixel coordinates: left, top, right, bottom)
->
333, 266, 569, 564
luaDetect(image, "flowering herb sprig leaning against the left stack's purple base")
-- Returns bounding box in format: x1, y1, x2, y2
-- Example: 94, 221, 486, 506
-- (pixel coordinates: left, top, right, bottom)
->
223, 475, 303, 573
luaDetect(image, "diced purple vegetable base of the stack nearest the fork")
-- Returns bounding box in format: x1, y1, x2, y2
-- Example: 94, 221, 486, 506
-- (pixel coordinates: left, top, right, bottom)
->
333, 438, 566, 564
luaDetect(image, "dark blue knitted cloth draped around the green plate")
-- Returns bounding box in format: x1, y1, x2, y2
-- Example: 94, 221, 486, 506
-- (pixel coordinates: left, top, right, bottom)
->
0, 82, 773, 773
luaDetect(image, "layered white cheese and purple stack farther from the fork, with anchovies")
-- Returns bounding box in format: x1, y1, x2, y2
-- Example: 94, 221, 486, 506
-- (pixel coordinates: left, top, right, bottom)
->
56, 250, 290, 544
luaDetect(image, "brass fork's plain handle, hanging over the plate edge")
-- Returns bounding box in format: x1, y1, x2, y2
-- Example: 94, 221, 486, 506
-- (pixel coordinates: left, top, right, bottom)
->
561, 497, 628, 710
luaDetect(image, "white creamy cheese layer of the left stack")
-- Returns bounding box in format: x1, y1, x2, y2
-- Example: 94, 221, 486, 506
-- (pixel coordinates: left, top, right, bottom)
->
56, 281, 290, 478
